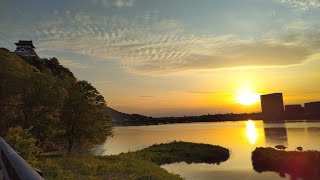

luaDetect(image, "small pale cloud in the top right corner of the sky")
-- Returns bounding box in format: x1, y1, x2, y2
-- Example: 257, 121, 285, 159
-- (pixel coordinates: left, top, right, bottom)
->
281, 0, 320, 10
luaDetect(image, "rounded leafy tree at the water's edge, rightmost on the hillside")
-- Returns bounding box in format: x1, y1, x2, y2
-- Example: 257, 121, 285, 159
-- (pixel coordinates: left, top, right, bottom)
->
61, 81, 112, 153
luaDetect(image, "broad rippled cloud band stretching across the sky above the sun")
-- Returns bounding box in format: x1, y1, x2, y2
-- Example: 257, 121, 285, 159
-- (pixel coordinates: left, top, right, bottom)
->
5, 12, 320, 75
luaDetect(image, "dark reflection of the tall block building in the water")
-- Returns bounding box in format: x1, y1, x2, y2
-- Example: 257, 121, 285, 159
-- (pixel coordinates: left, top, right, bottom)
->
264, 122, 288, 146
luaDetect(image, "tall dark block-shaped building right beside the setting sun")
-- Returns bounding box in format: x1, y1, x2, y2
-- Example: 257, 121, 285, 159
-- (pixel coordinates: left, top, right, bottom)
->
260, 93, 284, 119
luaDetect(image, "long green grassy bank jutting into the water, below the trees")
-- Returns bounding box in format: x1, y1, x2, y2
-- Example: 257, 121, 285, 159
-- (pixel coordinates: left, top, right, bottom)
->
39, 142, 229, 179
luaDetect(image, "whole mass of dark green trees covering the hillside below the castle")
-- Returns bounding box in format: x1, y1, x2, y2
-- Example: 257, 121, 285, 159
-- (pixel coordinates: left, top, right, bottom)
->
0, 48, 112, 154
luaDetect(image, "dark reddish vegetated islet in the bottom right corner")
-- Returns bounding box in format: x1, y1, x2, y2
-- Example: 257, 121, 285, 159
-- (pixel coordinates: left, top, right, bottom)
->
252, 148, 320, 179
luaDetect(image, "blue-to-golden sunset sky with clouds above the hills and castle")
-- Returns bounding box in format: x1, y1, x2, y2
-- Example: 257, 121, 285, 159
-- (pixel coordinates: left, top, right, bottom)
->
0, 0, 320, 116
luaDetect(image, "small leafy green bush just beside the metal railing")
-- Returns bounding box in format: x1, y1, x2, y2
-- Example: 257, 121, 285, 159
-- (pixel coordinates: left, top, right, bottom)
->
4, 126, 39, 166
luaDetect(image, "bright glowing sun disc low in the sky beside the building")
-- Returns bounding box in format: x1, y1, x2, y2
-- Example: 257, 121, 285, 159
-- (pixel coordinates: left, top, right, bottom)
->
236, 86, 260, 106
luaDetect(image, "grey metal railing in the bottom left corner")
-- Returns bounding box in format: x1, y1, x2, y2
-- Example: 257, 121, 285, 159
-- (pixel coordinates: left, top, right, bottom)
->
0, 138, 43, 180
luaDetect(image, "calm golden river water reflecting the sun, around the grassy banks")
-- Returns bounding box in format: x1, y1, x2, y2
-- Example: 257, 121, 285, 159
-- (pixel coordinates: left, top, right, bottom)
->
95, 120, 320, 180
